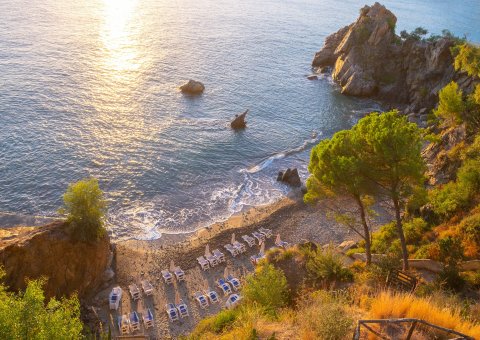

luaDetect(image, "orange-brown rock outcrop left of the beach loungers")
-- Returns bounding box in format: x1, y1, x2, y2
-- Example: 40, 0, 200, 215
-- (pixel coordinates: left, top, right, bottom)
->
0, 222, 111, 298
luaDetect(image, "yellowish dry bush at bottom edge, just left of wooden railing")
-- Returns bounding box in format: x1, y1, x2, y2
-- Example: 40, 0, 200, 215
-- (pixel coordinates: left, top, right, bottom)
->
298, 292, 353, 340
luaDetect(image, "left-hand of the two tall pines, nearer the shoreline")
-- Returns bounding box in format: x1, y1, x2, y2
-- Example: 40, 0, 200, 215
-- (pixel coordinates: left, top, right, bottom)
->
304, 130, 372, 264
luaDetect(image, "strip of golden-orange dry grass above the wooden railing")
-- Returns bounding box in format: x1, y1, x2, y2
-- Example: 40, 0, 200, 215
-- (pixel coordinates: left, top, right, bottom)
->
370, 292, 480, 339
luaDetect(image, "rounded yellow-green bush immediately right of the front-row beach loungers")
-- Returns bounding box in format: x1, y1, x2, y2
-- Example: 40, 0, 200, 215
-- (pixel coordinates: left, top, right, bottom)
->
242, 263, 289, 314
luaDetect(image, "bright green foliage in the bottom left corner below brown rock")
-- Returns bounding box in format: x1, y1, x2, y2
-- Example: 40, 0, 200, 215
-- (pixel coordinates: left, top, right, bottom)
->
0, 272, 83, 340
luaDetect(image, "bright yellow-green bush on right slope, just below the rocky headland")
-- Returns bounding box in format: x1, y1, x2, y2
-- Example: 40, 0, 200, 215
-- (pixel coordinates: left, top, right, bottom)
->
434, 81, 466, 125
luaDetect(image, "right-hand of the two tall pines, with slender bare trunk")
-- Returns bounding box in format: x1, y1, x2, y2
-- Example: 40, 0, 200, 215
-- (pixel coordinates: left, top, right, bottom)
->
353, 110, 425, 269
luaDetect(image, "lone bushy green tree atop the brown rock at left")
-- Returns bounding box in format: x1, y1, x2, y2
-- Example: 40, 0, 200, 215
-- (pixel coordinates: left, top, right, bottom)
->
60, 178, 107, 241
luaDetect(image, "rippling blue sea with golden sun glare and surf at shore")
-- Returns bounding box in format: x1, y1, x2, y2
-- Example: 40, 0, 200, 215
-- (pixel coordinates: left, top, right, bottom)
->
0, 0, 480, 239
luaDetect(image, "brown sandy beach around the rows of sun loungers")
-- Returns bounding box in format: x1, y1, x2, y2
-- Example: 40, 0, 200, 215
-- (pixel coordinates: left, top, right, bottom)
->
88, 194, 392, 339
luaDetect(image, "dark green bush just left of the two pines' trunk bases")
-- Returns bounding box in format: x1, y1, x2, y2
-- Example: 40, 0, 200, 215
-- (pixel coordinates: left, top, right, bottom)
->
306, 247, 353, 287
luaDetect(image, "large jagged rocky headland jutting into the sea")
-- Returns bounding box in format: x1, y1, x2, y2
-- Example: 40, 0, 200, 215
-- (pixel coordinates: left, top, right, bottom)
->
312, 2, 472, 113
